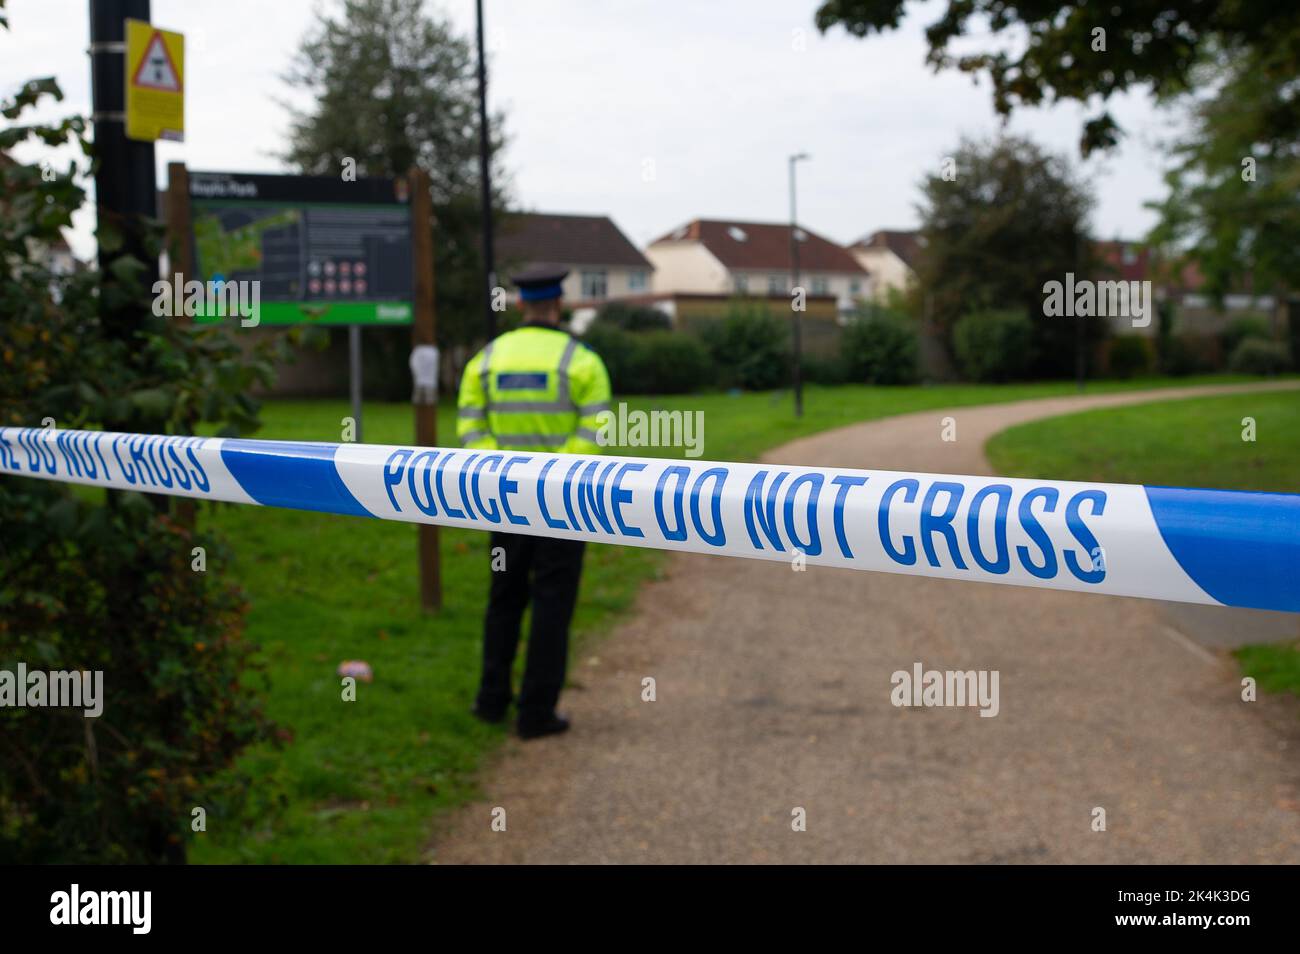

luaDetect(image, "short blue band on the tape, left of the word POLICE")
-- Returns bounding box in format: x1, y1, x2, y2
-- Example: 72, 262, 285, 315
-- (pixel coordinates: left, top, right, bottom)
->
221, 439, 374, 517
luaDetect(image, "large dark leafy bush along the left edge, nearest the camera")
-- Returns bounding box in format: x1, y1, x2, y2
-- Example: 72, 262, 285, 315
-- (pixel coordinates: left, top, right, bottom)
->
0, 70, 281, 863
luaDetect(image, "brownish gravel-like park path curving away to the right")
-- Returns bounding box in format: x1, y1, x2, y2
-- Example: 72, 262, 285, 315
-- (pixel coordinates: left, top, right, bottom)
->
429, 385, 1300, 863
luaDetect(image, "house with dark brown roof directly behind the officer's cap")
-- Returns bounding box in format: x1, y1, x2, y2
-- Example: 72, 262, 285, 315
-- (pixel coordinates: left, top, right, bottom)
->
495, 212, 654, 316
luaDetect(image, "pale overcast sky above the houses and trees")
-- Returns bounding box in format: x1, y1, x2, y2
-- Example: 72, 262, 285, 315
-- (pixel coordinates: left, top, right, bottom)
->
0, 0, 1169, 257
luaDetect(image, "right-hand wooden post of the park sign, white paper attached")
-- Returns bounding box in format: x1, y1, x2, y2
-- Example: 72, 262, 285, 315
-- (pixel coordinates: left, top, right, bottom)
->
408, 169, 442, 612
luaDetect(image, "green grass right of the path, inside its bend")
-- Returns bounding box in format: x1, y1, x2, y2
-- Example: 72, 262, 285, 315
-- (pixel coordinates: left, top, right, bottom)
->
985, 391, 1300, 694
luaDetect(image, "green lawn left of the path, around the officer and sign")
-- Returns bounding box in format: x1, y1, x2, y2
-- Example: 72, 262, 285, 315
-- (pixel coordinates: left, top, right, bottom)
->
191, 377, 1269, 863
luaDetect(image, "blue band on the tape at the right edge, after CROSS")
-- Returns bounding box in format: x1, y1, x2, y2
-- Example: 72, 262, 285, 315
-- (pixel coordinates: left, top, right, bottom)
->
1144, 487, 1300, 612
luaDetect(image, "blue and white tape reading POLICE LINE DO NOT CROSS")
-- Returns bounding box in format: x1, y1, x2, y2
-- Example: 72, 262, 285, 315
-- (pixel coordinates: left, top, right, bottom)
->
0, 428, 1300, 612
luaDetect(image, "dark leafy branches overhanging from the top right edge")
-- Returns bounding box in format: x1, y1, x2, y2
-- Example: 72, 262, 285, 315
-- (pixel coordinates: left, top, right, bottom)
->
816, 0, 1300, 155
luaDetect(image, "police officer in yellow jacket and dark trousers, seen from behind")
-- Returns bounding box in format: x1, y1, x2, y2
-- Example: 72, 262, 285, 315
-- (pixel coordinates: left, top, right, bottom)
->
456, 268, 610, 738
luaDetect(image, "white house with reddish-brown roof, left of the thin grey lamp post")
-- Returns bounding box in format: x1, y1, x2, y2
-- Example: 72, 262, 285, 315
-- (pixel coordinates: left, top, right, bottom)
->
646, 218, 868, 312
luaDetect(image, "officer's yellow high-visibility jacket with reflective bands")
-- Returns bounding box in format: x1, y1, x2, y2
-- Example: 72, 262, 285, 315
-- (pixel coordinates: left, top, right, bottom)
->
456, 325, 611, 454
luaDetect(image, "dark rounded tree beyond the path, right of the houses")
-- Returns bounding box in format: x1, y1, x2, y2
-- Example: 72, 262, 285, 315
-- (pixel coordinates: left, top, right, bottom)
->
918, 136, 1102, 374
